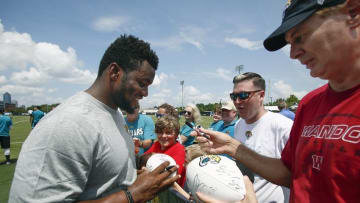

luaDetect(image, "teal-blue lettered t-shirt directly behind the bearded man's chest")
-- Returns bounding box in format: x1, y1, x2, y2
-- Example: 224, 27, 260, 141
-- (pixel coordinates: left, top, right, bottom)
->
125, 114, 156, 155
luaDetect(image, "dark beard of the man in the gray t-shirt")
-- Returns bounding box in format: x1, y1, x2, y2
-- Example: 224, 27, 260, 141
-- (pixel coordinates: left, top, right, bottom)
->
113, 74, 136, 114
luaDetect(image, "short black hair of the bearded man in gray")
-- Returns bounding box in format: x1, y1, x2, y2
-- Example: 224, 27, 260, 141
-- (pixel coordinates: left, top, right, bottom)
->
97, 35, 159, 78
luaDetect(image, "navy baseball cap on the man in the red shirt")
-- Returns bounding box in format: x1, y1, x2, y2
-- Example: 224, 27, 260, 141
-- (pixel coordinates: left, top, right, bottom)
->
264, 0, 346, 51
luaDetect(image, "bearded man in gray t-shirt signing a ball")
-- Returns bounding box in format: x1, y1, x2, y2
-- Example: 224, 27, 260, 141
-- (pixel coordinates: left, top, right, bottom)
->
9, 35, 179, 202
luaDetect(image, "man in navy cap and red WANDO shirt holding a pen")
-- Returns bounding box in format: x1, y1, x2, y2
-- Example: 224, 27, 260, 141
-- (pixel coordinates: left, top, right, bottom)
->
198, 0, 360, 202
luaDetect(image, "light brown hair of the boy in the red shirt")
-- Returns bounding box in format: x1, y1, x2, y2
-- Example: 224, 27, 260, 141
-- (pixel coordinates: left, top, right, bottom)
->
155, 115, 180, 136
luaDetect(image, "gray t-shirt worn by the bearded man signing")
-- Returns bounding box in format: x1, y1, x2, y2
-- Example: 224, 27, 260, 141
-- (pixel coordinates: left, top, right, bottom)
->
9, 92, 136, 203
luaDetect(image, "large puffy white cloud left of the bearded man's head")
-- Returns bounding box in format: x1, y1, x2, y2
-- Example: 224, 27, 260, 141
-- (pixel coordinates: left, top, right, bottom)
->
0, 22, 96, 85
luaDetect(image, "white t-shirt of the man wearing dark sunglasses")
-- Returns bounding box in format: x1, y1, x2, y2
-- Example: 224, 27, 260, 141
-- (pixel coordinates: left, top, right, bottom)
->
235, 112, 293, 203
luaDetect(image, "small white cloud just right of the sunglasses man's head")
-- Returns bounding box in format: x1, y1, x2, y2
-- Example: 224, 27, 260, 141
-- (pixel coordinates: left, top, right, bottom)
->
271, 80, 308, 99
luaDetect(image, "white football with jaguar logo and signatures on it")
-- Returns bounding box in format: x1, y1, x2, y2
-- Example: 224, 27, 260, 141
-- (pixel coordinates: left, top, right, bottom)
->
186, 155, 246, 202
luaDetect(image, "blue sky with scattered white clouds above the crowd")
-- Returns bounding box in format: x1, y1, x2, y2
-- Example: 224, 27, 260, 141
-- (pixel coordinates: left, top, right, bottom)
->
0, 0, 326, 108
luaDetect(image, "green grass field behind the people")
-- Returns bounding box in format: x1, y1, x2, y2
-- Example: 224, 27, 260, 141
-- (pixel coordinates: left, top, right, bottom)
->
0, 116, 212, 203
